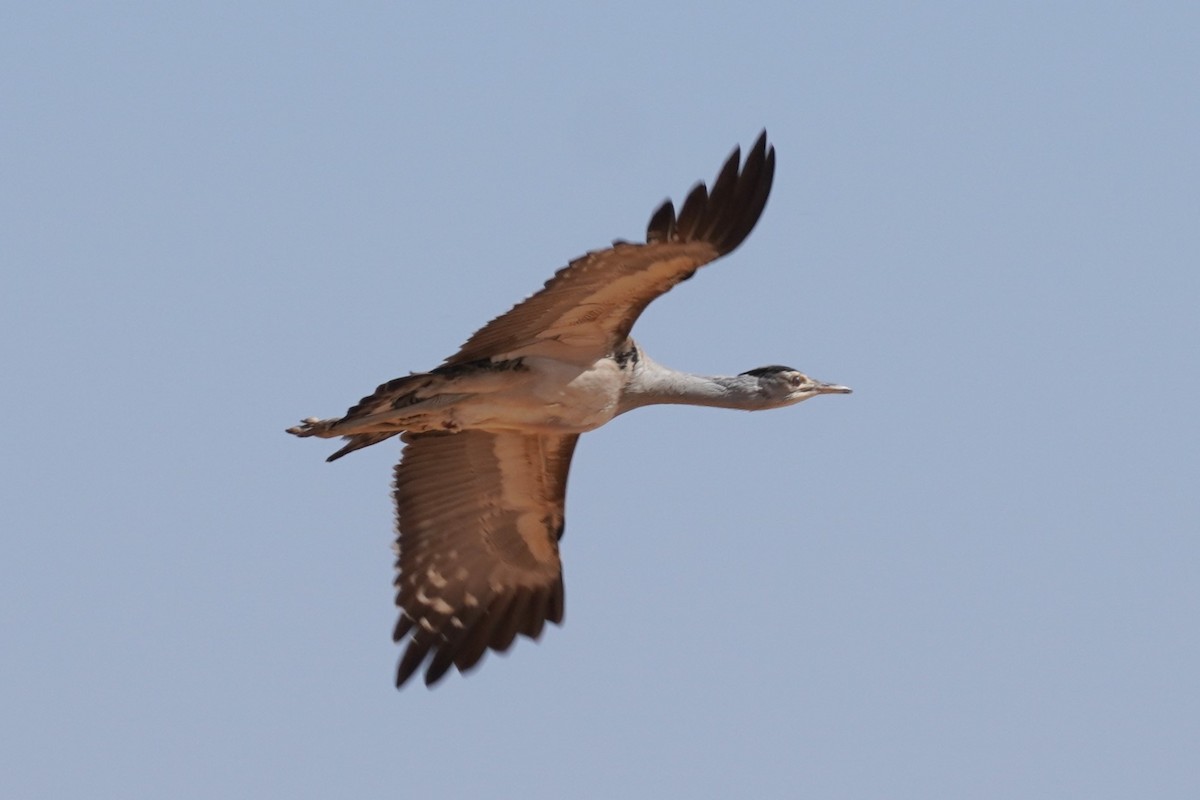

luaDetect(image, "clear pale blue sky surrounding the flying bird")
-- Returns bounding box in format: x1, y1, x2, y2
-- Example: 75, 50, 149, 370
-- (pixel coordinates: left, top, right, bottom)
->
0, 2, 1200, 800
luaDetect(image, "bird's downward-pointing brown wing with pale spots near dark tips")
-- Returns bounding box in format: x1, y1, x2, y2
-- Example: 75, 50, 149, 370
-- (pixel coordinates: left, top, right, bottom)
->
395, 431, 578, 686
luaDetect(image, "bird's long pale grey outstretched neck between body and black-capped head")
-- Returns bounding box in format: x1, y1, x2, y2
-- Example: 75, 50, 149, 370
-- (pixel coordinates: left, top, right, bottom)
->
618, 354, 766, 414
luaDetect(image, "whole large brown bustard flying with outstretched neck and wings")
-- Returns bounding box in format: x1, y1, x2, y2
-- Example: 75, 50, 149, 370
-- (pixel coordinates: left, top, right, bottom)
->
287, 131, 851, 687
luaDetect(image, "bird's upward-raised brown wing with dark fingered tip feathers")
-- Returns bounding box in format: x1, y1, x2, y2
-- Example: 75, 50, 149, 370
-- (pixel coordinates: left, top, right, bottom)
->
446, 131, 775, 363
